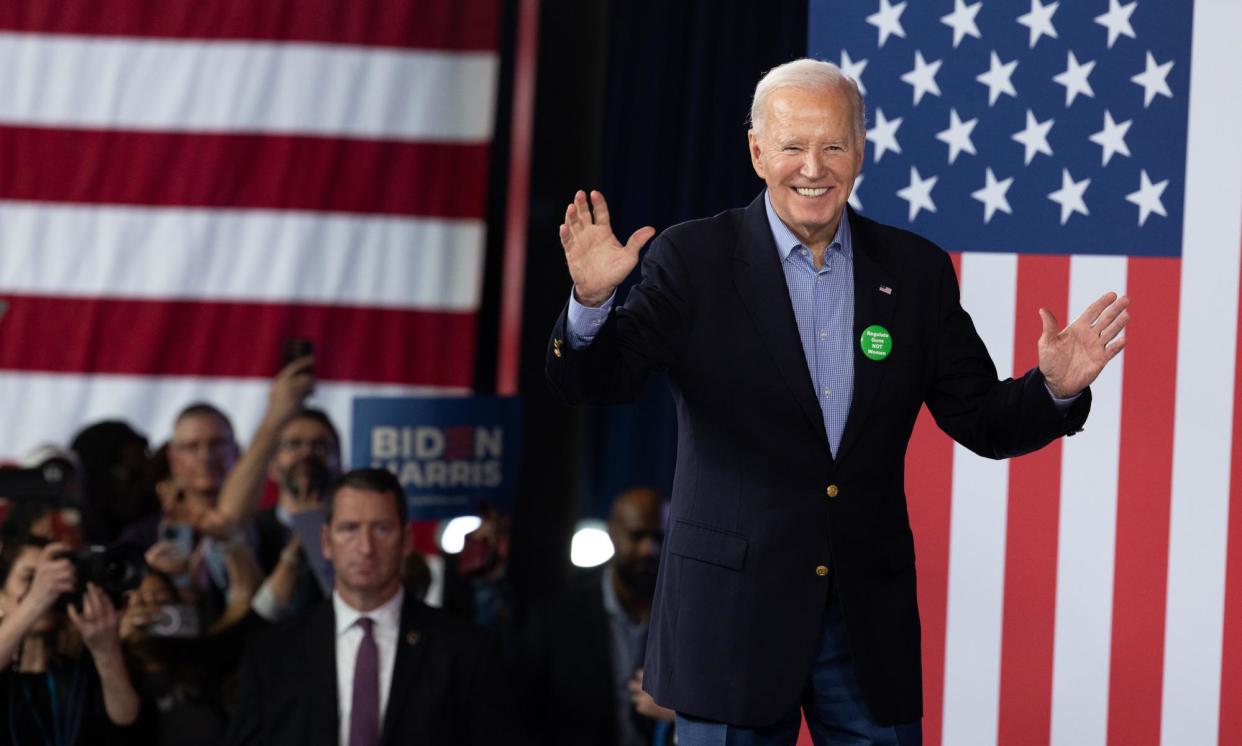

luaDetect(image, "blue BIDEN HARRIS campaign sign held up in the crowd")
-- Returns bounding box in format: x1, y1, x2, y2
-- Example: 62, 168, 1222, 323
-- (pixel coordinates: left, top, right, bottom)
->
353, 396, 522, 520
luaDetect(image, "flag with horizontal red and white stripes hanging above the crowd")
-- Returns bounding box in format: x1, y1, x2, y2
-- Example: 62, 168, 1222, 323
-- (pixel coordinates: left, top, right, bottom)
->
0, 0, 501, 459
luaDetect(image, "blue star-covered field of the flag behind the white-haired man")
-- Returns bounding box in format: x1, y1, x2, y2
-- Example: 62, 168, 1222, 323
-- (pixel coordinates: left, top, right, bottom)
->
807, 0, 1194, 257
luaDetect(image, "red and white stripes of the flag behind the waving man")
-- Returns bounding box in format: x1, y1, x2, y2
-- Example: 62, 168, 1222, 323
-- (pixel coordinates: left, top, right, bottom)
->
908, 1, 1242, 746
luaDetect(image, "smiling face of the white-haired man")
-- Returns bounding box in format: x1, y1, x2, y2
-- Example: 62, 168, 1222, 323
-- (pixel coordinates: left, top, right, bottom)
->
749, 84, 864, 249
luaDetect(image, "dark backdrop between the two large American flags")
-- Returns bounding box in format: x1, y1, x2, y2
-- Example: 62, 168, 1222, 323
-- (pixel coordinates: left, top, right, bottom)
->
477, 0, 806, 598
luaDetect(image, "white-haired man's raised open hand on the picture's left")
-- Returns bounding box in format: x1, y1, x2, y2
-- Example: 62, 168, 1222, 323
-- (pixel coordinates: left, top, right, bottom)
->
560, 190, 656, 307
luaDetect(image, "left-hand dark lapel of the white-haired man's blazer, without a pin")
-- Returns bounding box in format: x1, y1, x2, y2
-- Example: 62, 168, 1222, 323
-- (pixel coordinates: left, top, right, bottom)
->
733, 194, 828, 451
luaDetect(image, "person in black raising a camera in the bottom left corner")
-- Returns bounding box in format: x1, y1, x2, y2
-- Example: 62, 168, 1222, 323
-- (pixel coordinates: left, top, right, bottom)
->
0, 536, 140, 745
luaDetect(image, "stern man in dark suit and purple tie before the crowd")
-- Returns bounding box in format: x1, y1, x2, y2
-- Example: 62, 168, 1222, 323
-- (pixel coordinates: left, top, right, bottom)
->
226, 469, 524, 746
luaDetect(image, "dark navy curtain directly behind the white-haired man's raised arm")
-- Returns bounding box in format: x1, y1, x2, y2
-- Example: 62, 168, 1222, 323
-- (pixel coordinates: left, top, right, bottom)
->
579, 0, 806, 516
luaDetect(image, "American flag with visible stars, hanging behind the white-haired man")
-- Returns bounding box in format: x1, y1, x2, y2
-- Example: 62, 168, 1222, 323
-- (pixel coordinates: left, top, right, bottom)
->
809, 0, 1242, 746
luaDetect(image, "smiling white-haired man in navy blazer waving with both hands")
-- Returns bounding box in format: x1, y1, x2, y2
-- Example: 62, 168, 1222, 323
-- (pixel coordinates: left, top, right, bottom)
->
548, 60, 1129, 746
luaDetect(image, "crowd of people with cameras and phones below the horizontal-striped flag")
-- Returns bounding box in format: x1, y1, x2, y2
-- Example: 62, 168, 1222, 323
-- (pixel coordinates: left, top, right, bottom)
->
0, 356, 673, 746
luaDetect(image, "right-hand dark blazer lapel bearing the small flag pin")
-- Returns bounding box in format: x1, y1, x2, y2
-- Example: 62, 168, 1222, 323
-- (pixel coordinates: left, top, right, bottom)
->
837, 210, 902, 462
